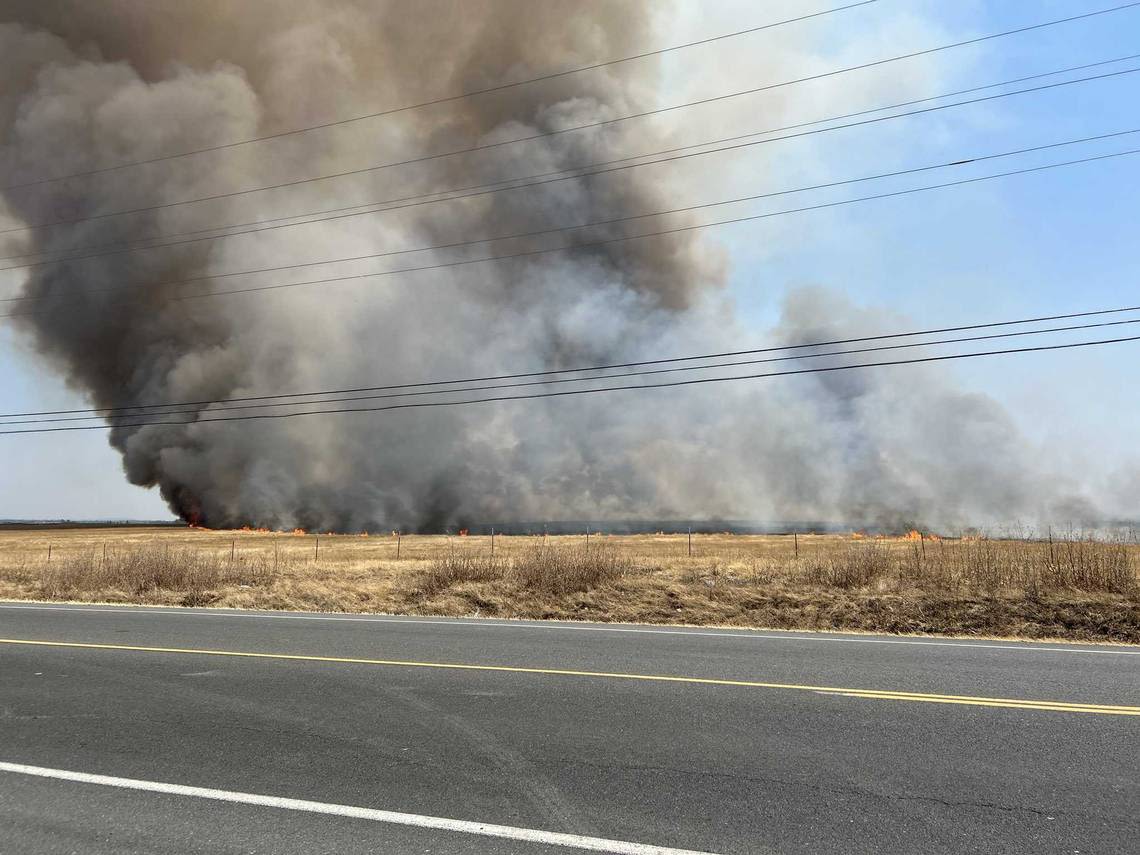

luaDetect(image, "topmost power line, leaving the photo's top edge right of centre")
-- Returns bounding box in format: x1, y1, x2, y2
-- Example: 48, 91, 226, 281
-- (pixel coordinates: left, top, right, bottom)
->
0, 0, 880, 192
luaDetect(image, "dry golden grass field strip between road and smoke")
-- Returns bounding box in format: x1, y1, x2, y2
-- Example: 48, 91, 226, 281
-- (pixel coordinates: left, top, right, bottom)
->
0, 527, 1140, 642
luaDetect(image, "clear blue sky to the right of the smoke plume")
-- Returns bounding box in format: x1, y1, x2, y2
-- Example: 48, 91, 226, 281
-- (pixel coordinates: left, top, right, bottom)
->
679, 1, 1140, 478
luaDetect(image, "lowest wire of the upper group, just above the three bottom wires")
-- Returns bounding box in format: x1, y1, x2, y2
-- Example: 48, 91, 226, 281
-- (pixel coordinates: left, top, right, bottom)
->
0, 142, 1140, 318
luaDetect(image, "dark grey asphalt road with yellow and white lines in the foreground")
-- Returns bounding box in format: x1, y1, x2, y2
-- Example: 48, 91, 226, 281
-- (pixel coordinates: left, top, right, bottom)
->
0, 604, 1140, 855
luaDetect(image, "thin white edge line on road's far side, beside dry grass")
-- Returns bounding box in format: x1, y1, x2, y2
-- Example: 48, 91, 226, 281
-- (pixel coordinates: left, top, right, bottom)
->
0, 603, 1140, 656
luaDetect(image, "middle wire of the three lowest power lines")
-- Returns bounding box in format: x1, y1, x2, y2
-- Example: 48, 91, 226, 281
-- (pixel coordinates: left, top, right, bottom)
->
0, 318, 1140, 426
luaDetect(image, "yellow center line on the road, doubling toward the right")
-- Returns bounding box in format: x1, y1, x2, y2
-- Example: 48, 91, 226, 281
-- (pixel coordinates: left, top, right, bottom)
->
0, 638, 1140, 716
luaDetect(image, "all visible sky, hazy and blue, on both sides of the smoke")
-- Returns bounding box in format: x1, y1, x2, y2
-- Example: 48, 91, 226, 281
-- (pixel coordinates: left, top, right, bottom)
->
0, 0, 1140, 519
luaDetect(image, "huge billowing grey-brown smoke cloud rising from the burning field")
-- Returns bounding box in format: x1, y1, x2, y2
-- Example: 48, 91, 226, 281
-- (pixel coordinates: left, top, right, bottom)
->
0, 0, 1112, 530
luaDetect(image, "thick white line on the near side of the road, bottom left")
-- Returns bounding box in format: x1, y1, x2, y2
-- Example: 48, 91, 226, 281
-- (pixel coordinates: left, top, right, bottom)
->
0, 762, 713, 855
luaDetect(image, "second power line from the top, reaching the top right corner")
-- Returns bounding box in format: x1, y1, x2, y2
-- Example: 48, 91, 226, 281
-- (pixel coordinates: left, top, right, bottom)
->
0, 0, 1140, 235
